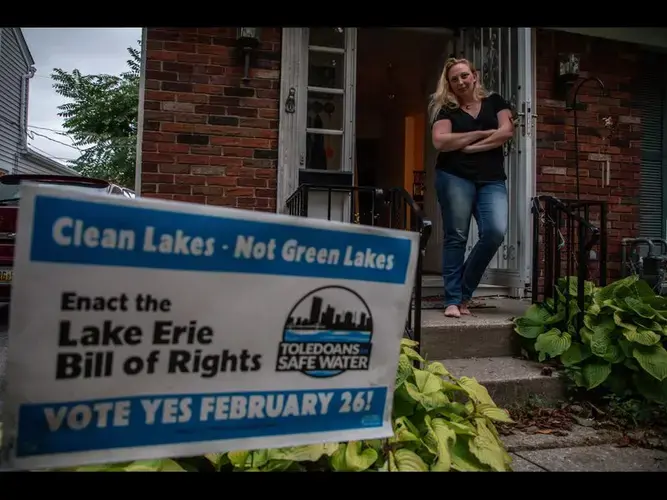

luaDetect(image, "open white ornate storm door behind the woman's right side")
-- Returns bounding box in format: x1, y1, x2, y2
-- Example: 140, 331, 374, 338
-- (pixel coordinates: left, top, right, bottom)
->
455, 28, 534, 295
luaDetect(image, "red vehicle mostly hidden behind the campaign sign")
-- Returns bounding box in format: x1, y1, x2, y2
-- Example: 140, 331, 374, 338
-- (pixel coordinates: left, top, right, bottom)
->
0, 174, 134, 304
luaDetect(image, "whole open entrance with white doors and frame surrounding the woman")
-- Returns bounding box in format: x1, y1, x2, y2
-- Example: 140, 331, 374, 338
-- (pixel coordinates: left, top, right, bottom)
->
278, 27, 534, 295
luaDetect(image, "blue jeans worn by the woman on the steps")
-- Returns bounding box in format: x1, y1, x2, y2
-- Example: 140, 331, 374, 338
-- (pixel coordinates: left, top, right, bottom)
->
435, 170, 508, 306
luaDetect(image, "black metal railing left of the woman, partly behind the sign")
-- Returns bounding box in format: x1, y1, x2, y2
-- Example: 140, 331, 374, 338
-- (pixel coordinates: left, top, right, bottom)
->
286, 184, 431, 352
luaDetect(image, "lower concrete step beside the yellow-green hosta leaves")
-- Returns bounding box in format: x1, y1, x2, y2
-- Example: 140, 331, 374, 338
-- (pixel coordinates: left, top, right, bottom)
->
431, 356, 565, 406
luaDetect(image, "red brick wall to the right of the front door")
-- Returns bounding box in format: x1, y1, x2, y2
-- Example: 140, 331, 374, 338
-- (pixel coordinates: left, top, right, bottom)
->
536, 30, 644, 278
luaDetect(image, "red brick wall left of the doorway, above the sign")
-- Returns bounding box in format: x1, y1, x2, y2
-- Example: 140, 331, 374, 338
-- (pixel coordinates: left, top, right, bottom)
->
141, 28, 280, 212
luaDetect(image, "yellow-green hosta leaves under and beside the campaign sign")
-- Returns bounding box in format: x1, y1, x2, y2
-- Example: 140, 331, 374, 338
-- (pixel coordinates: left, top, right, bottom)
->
60, 339, 512, 472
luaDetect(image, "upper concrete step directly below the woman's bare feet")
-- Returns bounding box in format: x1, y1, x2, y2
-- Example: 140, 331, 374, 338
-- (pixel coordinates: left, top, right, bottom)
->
421, 298, 530, 359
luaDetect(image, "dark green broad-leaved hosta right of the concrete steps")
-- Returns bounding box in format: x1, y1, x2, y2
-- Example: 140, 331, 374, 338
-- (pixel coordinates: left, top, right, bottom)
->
514, 276, 667, 402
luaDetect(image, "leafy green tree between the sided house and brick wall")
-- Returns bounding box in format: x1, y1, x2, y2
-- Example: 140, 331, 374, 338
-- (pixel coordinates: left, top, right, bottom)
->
51, 41, 141, 188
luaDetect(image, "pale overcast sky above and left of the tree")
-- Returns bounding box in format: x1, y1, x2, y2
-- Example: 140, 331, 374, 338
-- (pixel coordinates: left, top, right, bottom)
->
22, 28, 141, 163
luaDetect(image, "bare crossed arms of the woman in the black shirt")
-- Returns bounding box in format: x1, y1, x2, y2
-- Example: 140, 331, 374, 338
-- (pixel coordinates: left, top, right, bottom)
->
432, 109, 514, 153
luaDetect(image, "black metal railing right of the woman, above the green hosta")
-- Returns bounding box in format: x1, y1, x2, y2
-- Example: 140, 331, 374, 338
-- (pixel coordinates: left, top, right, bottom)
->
531, 196, 607, 329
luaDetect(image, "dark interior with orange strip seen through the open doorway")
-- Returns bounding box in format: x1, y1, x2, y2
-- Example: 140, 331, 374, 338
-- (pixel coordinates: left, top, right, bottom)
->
354, 28, 453, 232
